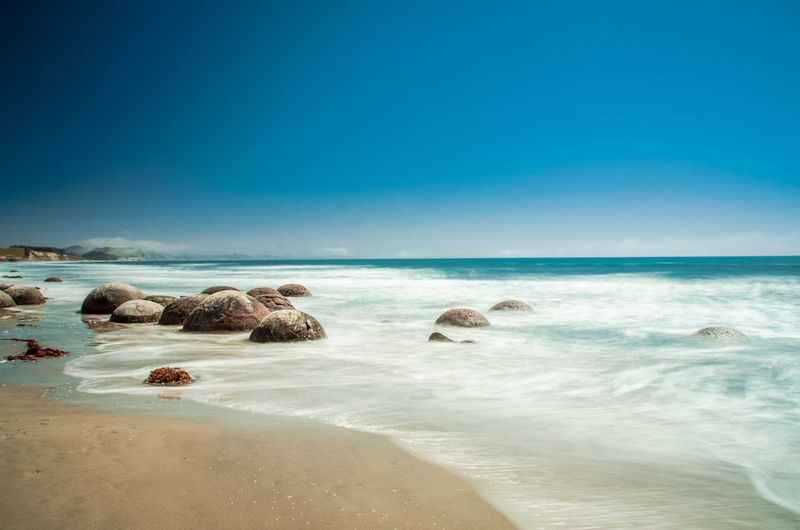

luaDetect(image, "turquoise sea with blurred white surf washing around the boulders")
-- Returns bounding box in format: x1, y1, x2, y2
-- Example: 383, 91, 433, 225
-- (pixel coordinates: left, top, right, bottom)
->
0, 257, 800, 529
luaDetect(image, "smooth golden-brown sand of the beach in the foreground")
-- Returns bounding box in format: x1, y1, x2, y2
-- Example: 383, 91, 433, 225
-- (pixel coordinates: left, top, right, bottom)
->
0, 386, 513, 530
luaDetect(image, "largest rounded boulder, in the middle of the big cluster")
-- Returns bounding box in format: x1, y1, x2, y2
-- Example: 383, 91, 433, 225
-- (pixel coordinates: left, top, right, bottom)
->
183, 291, 269, 331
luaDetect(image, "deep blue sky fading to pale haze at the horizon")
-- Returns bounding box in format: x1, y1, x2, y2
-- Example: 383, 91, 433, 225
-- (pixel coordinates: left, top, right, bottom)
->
0, 1, 800, 257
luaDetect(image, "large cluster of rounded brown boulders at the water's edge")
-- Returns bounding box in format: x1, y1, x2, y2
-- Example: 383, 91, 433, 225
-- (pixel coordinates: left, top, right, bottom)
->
75, 283, 326, 342
